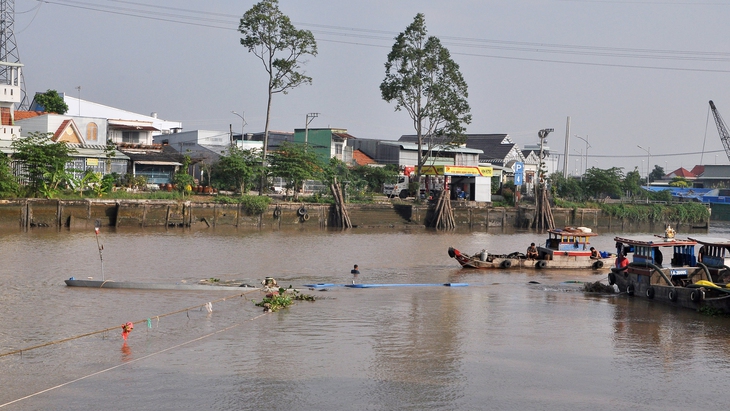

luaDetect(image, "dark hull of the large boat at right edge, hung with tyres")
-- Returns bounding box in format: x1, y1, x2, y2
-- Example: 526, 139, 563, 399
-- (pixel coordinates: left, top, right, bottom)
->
608, 268, 730, 314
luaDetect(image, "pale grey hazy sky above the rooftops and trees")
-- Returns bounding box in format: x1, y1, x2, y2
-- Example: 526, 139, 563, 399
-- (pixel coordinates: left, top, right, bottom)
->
7, 0, 730, 175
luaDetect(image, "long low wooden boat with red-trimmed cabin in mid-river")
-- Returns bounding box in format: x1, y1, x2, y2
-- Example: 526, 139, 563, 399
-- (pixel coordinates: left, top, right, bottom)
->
449, 227, 614, 270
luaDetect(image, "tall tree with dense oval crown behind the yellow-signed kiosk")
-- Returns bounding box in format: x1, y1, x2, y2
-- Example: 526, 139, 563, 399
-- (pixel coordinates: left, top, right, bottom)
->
380, 13, 471, 181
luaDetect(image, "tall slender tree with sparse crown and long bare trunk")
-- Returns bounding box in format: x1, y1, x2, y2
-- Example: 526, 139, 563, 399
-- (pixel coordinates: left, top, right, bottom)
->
238, 0, 317, 164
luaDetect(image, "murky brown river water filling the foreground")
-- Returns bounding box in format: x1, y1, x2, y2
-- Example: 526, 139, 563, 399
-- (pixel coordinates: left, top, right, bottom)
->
0, 225, 730, 411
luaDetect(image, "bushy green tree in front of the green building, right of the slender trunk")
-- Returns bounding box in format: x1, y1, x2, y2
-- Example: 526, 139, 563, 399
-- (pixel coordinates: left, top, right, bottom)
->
269, 142, 322, 197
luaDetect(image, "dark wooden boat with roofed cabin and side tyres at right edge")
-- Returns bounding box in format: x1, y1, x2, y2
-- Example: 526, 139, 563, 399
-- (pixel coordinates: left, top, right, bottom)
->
608, 227, 730, 313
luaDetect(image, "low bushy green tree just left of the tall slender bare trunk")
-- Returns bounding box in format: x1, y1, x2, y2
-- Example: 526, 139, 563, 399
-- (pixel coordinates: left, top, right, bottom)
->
211, 146, 261, 194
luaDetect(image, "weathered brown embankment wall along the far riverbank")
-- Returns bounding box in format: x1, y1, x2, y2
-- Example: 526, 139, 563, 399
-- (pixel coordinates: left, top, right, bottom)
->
0, 199, 709, 232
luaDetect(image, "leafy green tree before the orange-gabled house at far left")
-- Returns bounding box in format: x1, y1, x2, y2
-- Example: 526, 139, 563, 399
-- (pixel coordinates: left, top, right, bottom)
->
11, 132, 76, 198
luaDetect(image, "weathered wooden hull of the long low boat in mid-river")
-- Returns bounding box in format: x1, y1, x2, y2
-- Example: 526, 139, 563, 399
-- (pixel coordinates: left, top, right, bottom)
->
449, 247, 613, 270
